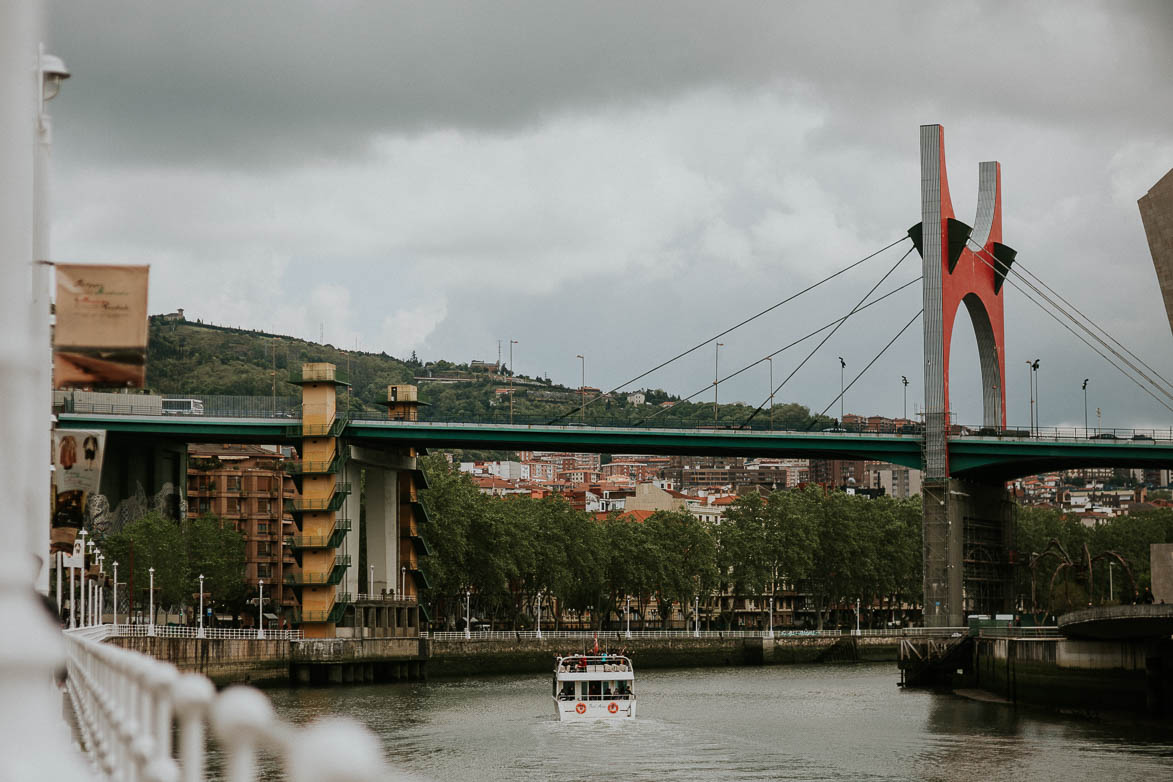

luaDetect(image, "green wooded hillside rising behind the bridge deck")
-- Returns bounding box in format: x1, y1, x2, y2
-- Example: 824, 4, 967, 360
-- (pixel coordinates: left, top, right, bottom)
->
147, 315, 829, 429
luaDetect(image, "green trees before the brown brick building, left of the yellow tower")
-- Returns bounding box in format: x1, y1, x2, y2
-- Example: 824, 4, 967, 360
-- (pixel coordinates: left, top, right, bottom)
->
97, 512, 249, 614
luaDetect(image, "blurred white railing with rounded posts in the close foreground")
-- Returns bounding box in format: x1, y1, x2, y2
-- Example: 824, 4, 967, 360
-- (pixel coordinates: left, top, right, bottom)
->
65, 626, 389, 782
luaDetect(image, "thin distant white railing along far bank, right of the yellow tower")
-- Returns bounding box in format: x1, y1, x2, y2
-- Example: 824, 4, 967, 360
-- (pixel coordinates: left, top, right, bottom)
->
420, 627, 969, 641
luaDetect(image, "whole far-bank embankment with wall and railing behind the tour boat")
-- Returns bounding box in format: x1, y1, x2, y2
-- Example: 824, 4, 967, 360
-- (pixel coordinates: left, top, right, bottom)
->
108, 625, 961, 686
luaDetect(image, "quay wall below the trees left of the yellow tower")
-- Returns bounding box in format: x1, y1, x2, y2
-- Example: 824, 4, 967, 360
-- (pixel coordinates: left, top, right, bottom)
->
108, 637, 290, 687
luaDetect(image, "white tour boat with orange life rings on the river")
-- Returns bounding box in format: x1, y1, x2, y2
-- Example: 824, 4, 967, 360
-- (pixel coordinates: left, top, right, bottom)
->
554, 653, 636, 720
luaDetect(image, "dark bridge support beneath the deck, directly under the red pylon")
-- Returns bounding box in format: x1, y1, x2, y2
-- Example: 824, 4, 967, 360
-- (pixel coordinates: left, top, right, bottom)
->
923, 478, 1017, 627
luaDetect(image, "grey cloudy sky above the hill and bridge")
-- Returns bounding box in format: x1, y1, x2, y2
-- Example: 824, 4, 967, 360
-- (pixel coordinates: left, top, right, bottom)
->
48, 0, 1173, 426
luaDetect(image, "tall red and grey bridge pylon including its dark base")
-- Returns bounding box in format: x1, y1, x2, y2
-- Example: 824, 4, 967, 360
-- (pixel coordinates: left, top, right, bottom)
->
909, 124, 1015, 626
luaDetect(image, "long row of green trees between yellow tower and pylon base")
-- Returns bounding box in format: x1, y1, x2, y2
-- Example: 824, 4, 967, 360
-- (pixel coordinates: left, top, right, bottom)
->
422, 456, 921, 627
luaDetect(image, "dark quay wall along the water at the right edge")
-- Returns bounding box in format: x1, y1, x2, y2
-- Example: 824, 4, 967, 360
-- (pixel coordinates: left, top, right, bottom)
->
972, 638, 1173, 718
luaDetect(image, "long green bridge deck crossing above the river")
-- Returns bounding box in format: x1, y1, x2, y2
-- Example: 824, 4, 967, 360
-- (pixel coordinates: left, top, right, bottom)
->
57, 413, 1173, 483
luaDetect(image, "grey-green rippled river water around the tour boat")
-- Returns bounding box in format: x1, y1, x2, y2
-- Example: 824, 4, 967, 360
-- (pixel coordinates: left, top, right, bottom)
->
270, 664, 1173, 782
